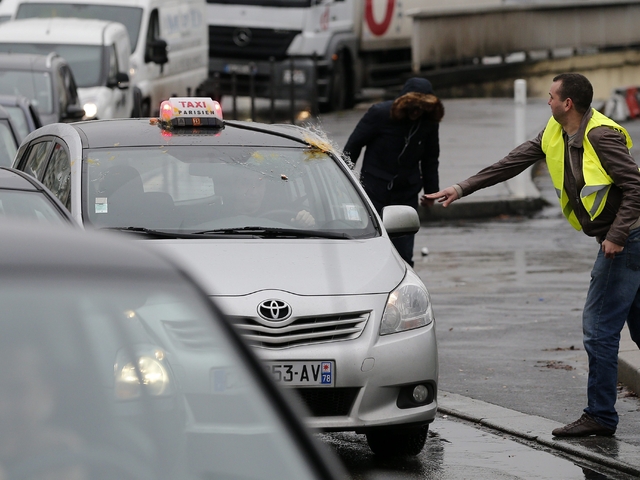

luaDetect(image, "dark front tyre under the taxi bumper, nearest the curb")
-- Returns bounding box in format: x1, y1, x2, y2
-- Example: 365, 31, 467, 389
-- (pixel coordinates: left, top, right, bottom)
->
366, 425, 429, 457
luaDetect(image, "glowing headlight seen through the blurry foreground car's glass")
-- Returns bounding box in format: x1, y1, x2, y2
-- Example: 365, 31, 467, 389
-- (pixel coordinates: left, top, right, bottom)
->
114, 348, 170, 400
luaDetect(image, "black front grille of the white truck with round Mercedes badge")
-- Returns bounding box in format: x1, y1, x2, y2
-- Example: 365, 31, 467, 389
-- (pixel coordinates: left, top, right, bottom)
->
209, 25, 300, 60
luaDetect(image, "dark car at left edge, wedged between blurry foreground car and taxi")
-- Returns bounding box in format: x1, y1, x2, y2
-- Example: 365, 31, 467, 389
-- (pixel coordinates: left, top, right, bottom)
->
0, 166, 79, 227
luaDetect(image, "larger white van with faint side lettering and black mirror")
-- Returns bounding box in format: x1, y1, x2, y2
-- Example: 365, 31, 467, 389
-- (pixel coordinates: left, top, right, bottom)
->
14, 0, 209, 117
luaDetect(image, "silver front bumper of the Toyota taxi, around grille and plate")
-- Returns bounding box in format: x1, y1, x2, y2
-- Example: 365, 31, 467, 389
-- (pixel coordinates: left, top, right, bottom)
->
219, 291, 438, 432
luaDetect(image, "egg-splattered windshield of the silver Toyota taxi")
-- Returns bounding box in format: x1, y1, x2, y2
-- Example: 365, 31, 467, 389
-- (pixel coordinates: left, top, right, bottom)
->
83, 145, 378, 238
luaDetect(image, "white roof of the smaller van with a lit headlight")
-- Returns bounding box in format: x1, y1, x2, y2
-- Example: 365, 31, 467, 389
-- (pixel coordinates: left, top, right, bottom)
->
0, 17, 125, 45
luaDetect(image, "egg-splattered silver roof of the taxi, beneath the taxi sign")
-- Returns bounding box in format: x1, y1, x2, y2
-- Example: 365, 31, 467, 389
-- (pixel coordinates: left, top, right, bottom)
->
69, 118, 319, 148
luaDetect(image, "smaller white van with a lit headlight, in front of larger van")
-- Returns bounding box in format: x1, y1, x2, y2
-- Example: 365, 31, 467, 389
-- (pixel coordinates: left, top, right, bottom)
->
0, 18, 133, 120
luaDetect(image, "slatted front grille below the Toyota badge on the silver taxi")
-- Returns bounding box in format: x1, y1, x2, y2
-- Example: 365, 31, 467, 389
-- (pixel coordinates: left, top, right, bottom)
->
232, 312, 370, 348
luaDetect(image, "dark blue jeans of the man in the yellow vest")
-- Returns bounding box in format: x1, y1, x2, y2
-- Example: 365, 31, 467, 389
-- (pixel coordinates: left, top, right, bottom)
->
582, 228, 640, 429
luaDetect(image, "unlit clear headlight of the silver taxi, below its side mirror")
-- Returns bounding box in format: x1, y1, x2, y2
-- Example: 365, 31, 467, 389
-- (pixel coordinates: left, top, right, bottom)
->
380, 270, 433, 335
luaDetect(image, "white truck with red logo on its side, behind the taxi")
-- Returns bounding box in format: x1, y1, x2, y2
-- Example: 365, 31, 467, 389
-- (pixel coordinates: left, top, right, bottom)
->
199, 0, 425, 111
